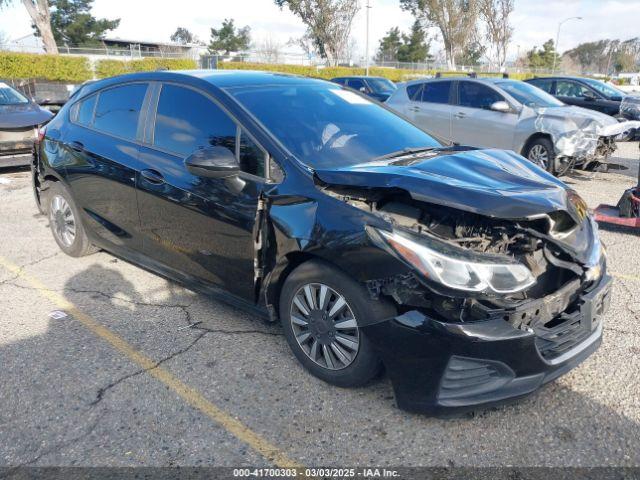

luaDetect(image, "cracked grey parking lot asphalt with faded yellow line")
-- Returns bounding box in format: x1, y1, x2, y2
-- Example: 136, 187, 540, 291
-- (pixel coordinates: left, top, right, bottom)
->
0, 154, 640, 466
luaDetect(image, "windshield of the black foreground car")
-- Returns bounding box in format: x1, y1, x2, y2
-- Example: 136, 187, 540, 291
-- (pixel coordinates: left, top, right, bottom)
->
228, 84, 440, 169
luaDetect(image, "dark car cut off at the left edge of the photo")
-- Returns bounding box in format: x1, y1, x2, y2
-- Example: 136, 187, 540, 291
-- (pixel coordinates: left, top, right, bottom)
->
0, 82, 53, 168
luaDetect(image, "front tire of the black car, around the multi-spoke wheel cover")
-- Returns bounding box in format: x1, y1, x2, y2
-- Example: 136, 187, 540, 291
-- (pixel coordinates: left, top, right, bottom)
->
280, 260, 396, 387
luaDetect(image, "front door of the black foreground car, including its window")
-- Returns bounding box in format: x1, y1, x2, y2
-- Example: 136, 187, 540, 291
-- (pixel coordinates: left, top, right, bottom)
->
138, 83, 267, 300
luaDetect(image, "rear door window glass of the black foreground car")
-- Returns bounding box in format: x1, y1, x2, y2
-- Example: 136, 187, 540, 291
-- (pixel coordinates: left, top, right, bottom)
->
93, 83, 147, 140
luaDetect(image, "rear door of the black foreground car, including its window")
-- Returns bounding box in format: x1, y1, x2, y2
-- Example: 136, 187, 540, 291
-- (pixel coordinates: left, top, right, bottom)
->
62, 83, 148, 251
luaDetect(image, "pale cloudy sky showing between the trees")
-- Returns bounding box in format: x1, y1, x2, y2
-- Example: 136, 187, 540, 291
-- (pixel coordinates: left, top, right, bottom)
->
0, 0, 640, 57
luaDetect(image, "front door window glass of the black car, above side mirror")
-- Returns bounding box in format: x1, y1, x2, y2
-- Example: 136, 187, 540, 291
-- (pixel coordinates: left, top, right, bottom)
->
153, 84, 236, 157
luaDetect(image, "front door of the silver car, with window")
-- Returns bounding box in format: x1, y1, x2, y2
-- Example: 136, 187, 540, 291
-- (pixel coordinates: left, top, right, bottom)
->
451, 80, 518, 150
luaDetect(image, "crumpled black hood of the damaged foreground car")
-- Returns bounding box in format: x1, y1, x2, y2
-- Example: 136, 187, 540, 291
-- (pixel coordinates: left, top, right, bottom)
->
315, 147, 584, 223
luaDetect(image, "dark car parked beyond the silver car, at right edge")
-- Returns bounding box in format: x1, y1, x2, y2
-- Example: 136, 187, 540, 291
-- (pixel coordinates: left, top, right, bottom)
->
525, 77, 640, 120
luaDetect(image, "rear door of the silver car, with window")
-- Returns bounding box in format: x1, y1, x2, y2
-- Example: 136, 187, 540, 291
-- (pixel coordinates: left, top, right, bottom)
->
407, 80, 453, 142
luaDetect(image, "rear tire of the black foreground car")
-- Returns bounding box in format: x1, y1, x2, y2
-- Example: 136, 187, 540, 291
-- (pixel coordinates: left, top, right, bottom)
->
46, 182, 98, 257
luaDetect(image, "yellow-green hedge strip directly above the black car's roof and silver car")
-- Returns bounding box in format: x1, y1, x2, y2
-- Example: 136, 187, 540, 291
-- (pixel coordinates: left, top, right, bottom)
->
218, 62, 534, 82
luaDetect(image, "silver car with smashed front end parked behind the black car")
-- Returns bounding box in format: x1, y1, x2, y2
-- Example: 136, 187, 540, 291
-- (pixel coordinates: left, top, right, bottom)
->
386, 77, 617, 175
